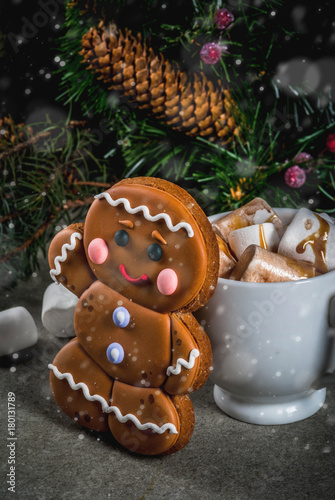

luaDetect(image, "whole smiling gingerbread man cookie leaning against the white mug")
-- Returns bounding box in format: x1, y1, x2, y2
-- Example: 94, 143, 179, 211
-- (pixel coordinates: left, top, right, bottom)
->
49, 177, 219, 455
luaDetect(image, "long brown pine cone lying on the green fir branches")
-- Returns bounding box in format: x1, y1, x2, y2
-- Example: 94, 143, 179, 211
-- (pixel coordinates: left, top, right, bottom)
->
80, 22, 239, 145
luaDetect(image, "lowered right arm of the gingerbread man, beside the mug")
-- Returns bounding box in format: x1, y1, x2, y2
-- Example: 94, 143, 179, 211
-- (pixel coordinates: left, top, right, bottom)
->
164, 313, 212, 395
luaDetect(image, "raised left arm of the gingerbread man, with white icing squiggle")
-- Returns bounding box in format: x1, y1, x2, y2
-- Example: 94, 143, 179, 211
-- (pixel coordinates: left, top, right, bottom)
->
48, 224, 96, 297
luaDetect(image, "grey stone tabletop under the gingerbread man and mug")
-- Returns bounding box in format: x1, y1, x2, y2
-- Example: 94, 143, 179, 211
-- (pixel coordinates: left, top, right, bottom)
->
0, 263, 335, 500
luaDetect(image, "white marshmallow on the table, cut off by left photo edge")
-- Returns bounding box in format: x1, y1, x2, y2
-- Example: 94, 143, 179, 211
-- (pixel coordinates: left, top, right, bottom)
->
0, 307, 38, 360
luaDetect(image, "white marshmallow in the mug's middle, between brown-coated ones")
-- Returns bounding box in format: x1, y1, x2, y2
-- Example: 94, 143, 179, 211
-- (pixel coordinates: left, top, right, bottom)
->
228, 222, 279, 259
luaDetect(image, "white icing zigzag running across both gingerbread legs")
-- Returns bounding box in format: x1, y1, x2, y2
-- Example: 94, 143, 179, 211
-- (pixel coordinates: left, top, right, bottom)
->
48, 363, 178, 434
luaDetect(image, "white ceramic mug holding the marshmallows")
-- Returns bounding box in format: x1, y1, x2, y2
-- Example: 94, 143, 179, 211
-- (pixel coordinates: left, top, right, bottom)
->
196, 209, 335, 425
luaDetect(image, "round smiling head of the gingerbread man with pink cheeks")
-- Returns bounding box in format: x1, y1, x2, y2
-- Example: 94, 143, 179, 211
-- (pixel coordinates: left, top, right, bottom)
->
84, 178, 220, 312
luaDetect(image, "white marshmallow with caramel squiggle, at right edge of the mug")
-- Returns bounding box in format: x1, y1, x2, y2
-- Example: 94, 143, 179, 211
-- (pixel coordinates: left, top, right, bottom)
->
278, 208, 335, 273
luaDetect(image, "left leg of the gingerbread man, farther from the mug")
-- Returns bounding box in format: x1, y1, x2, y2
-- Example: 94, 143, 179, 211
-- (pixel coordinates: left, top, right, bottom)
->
49, 338, 113, 432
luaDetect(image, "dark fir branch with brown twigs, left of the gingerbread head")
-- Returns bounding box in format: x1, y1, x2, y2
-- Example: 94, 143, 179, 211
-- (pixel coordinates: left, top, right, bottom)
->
0, 117, 117, 283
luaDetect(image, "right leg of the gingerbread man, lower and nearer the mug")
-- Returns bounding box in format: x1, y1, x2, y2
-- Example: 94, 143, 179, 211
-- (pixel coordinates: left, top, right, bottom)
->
108, 381, 194, 455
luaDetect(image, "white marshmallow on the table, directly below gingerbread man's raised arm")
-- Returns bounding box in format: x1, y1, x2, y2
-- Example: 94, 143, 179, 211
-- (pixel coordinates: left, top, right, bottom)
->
42, 283, 78, 337
